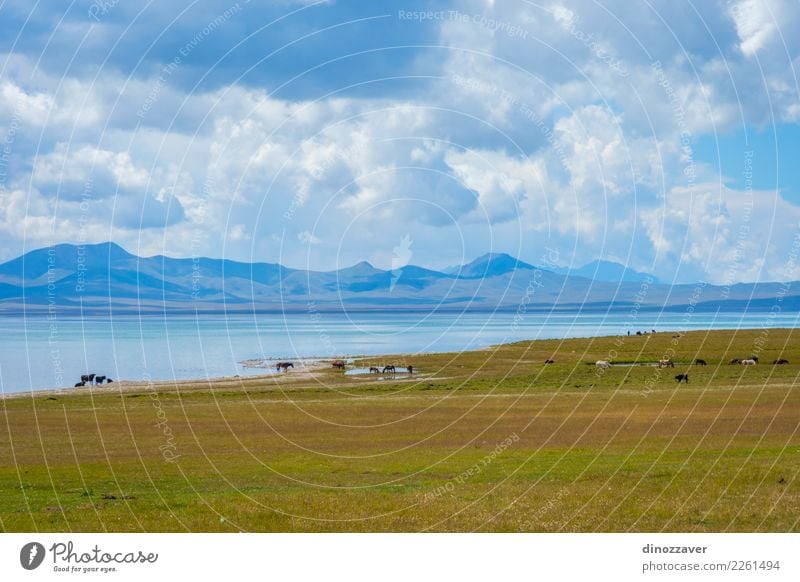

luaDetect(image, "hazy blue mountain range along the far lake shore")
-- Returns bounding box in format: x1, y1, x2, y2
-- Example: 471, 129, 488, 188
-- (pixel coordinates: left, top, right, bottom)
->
0, 243, 800, 313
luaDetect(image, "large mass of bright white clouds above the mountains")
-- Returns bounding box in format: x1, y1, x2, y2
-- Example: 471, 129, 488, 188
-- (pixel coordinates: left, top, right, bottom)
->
0, 0, 800, 280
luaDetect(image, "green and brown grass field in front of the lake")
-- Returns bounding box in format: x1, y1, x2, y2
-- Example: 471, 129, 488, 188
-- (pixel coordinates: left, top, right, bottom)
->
0, 329, 800, 532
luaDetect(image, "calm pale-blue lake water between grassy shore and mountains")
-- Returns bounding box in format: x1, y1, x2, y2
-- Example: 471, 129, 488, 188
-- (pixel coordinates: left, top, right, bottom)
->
0, 312, 800, 392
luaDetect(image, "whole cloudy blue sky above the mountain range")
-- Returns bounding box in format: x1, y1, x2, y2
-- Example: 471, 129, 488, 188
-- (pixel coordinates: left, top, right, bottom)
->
0, 0, 800, 284
